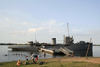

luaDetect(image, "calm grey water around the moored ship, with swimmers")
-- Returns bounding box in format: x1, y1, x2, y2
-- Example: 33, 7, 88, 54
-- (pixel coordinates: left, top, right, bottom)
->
0, 45, 100, 62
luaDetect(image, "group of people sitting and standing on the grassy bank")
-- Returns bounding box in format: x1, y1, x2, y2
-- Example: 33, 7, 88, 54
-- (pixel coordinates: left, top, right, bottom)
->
17, 54, 39, 66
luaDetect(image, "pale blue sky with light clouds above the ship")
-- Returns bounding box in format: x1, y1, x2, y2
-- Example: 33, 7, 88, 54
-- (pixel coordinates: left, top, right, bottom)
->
0, 0, 100, 44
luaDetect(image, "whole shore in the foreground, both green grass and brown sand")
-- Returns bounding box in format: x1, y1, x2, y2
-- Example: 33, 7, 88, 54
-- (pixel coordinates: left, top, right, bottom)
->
0, 57, 100, 67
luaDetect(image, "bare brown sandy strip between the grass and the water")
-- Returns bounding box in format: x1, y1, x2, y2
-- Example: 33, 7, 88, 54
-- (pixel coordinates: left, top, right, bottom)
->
44, 57, 100, 64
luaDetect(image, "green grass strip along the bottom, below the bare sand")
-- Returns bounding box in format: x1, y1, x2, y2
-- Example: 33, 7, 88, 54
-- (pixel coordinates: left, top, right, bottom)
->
0, 58, 100, 67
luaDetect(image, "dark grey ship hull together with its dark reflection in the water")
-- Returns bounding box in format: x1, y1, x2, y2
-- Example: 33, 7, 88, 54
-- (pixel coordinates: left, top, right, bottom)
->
45, 43, 93, 56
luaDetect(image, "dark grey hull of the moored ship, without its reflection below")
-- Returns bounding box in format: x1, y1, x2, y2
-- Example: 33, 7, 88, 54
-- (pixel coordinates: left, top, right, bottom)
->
45, 43, 92, 51
